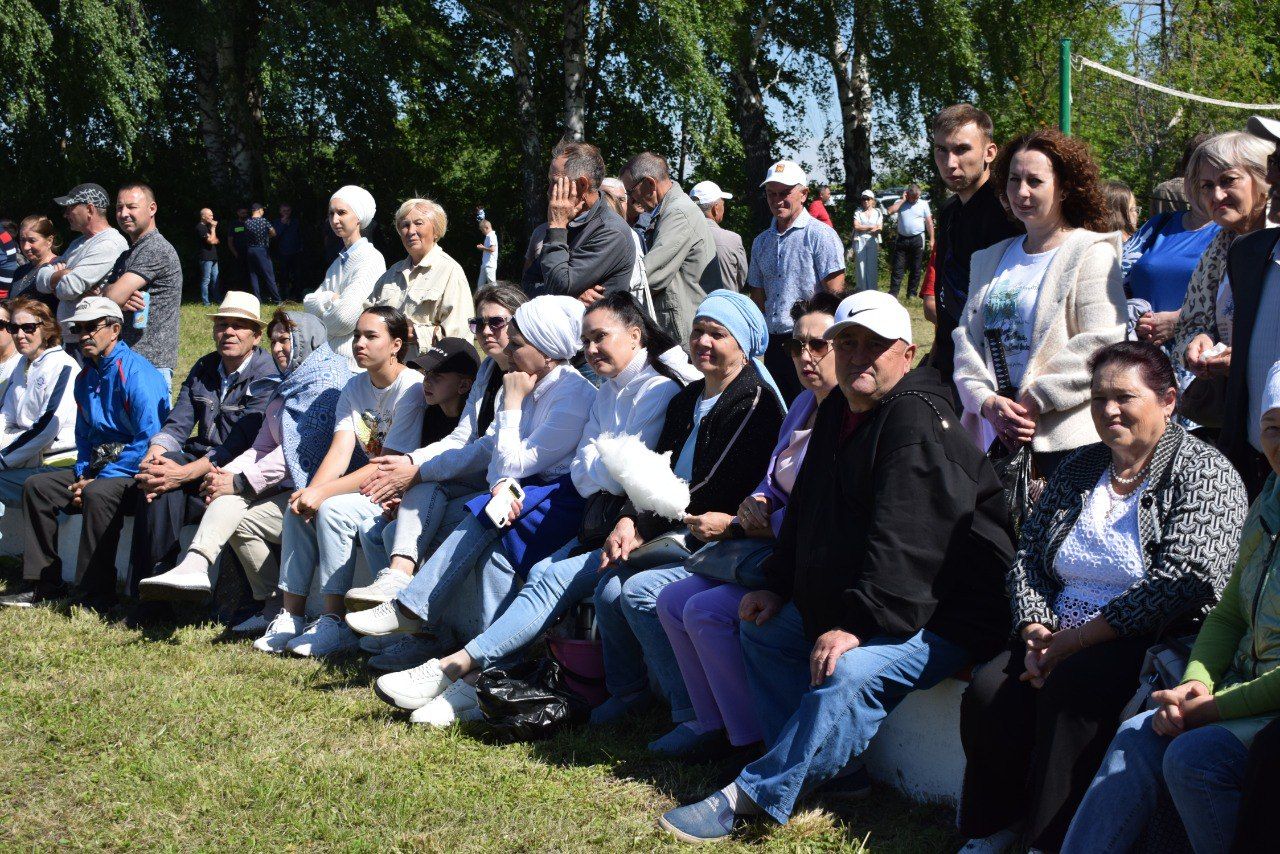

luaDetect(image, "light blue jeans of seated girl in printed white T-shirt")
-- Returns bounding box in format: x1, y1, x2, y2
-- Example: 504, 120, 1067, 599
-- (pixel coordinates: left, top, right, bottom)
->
280, 492, 383, 597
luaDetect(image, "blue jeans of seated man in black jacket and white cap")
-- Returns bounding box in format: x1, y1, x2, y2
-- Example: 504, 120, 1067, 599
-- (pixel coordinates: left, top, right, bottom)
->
737, 603, 970, 823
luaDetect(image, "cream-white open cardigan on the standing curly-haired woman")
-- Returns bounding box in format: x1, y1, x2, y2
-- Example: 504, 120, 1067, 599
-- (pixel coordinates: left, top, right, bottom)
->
952, 228, 1125, 452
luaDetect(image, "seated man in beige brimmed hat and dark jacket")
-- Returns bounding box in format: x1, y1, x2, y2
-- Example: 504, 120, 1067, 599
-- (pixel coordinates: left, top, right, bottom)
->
129, 291, 280, 614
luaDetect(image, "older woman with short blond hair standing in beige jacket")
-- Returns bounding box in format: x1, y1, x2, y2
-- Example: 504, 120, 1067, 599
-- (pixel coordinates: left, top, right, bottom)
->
372, 198, 475, 355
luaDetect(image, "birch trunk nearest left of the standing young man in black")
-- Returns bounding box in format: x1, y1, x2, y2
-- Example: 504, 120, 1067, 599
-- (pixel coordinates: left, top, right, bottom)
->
824, 0, 872, 197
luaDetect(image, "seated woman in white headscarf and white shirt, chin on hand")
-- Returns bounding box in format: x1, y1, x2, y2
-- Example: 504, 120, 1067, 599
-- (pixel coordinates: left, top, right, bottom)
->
347, 296, 595, 709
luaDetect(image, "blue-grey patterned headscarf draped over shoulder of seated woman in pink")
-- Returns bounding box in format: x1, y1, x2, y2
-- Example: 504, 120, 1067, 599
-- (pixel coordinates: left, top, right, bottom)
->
276, 311, 365, 489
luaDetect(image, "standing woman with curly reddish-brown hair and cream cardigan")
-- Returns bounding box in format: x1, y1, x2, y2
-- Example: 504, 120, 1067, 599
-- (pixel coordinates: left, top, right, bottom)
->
952, 128, 1125, 476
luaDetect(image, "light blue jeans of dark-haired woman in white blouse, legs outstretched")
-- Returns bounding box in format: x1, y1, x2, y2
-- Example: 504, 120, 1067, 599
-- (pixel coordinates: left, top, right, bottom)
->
465, 539, 600, 668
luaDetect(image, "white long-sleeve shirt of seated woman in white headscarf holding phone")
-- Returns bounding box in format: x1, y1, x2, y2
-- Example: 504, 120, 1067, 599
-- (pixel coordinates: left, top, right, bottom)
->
485, 365, 595, 484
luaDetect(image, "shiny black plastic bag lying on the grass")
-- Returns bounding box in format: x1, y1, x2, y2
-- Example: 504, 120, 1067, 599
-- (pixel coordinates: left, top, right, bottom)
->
476, 658, 591, 741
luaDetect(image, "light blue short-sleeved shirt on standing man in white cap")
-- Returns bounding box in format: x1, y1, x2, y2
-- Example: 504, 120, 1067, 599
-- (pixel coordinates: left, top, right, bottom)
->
746, 211, 845, 334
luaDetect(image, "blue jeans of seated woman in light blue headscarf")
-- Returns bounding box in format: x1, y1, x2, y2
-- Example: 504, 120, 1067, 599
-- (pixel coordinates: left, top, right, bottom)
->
595, 563, 694, 723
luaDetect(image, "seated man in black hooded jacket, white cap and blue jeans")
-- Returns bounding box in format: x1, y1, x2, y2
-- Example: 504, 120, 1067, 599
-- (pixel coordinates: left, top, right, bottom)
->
660, 291, 1014, 841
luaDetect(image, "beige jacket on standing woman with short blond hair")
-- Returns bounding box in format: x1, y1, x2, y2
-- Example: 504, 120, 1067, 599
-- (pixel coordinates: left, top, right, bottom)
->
370, 245, 475, 350
